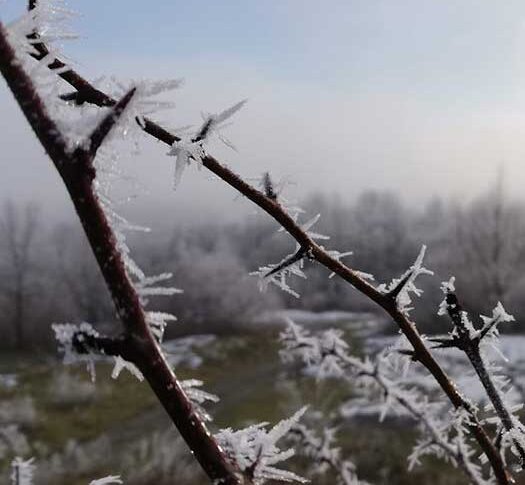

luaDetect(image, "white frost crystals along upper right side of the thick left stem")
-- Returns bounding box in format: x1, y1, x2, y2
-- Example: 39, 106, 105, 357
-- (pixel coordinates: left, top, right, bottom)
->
7, 5, 181, 344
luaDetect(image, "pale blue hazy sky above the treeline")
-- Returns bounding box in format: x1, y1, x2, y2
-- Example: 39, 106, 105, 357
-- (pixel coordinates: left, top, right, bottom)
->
0, 0, 525, 225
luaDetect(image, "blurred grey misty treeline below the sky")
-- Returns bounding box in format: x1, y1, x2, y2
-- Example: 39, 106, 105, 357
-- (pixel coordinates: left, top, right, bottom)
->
0, 182, 525, 348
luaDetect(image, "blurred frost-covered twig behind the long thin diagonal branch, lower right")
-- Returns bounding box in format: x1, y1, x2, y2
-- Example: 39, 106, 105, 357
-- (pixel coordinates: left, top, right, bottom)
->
280, 322, 491, 485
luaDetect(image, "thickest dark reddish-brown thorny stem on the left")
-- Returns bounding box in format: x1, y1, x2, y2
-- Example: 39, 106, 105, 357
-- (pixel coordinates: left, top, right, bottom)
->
0, 23, 247, 485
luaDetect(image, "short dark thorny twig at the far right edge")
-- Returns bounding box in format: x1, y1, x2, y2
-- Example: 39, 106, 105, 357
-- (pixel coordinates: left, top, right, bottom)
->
431, 292, 525, 467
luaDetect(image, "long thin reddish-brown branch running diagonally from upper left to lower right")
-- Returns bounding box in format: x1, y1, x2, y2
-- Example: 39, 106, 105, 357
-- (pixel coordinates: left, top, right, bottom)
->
11, 2, 513, 484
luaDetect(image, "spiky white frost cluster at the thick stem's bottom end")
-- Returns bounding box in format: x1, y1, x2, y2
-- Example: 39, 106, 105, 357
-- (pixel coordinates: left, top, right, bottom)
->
215, 407, 307, 485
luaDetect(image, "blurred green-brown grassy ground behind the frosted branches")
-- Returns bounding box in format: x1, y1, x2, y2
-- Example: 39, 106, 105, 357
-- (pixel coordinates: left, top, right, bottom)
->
0, 331, 474, 485
